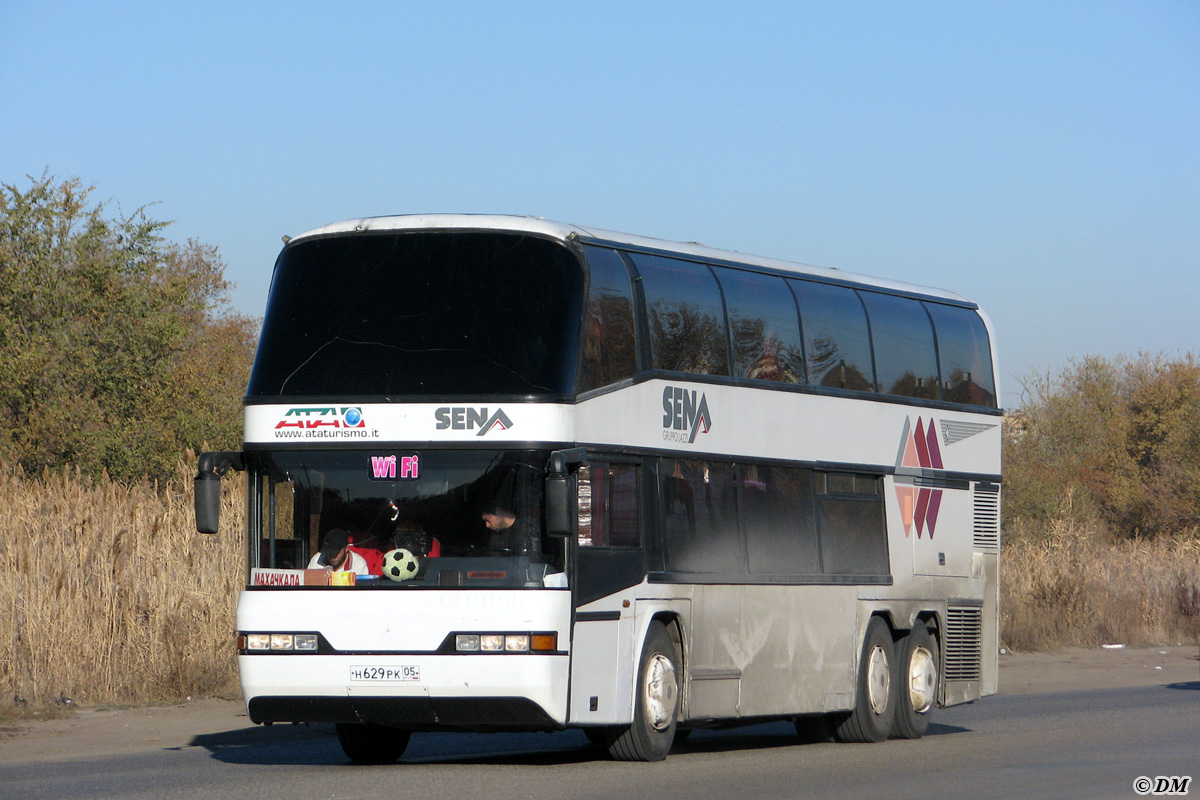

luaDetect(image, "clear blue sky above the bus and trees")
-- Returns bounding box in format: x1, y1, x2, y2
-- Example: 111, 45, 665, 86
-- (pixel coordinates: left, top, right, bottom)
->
0, 0, 1200, 407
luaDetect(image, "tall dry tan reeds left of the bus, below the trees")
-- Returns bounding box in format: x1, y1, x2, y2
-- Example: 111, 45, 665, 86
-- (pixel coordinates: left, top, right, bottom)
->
0, 459, 245, 708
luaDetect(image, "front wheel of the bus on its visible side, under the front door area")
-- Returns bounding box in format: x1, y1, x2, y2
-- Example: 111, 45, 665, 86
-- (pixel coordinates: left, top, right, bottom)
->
608, 621, 679, 762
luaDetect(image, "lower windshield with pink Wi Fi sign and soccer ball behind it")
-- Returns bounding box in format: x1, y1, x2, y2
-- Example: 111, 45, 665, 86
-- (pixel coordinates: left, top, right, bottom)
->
251, 450, 566, 588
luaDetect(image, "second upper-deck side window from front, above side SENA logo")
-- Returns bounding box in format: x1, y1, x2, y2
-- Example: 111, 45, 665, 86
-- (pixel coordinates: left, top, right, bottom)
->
632, 253, 730, 375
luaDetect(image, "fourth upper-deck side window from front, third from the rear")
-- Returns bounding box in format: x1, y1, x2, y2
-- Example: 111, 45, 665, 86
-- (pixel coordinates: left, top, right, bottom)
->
788, 279, 875, 392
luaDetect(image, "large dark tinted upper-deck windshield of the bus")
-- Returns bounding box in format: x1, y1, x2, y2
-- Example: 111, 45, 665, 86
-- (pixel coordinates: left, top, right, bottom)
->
247, 231, 583, 399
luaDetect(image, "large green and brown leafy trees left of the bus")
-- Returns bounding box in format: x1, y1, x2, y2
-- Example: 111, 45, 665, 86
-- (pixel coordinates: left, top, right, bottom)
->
0, 175, 257, 481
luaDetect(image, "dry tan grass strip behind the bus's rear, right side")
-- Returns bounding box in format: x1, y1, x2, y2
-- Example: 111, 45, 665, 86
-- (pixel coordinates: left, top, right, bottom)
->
1000, 519, 1200, 650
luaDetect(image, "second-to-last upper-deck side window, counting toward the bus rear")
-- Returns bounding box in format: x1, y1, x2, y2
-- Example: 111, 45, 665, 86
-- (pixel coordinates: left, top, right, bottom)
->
858, 291, 941, 399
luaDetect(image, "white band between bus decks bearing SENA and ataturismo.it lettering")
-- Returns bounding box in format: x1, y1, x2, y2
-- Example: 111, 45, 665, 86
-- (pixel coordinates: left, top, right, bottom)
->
245, 380, 1000, 475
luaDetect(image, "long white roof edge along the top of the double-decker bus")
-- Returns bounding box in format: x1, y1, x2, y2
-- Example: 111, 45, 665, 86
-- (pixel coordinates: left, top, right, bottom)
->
288, 213, 976, 306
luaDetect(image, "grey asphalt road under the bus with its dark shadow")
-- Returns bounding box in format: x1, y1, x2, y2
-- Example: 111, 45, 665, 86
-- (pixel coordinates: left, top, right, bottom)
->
0, 681, 1200, 800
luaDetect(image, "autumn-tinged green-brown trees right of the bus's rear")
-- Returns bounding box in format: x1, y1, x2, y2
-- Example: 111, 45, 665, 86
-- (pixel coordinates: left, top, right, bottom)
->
1004, 354, 1200, 537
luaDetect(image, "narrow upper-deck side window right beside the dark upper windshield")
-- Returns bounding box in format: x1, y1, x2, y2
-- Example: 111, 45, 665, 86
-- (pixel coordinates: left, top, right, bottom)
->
575, 247, 637, 393
